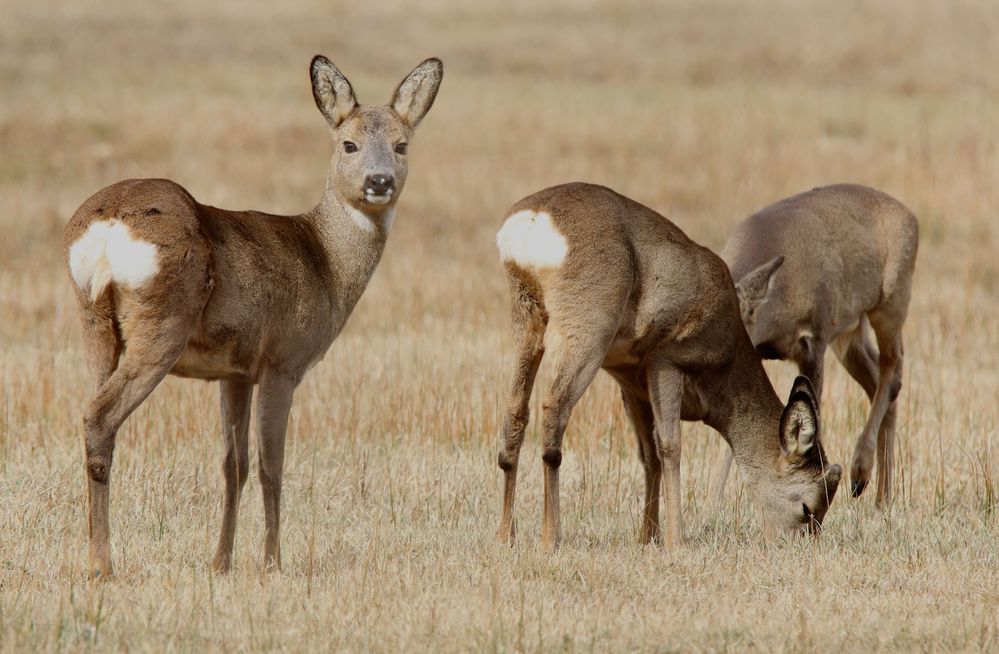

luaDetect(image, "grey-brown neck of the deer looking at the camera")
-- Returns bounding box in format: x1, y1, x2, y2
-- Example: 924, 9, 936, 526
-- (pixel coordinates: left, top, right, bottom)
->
309, 182, 395, 321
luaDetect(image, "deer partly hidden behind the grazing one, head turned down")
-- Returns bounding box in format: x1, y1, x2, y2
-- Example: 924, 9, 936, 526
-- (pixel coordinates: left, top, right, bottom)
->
715, 184, 919, 506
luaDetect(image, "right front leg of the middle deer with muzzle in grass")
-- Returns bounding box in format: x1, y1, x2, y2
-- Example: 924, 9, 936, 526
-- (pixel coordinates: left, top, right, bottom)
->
649, 360, 683, 547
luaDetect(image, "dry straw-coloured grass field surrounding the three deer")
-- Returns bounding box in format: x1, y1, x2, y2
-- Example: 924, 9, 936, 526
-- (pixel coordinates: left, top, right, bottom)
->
0, 0, 999, 652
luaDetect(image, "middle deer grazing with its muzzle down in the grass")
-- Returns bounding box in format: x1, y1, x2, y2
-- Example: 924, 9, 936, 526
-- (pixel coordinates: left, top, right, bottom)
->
496, 183, 842, 550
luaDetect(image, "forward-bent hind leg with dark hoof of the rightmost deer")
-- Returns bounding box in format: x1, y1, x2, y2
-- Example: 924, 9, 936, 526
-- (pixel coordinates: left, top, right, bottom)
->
850, 313, 903, 497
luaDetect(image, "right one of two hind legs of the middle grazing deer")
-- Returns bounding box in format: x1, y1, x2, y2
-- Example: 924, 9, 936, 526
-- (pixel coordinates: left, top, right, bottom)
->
541, 324, 613, 551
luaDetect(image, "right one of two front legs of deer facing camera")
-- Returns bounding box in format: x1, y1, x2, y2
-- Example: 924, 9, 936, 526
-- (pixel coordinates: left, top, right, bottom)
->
257, 370, 297, 570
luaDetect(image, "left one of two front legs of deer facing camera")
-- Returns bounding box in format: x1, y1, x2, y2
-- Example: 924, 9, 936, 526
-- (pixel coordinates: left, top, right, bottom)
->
212, 379, 253, 572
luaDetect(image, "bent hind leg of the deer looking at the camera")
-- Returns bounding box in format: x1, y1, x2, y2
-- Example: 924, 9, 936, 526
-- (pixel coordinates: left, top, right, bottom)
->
83, 307, 191, 578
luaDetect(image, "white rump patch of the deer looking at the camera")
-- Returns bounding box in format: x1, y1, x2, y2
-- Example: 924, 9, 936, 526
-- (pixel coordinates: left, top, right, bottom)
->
69, 220, 159, 300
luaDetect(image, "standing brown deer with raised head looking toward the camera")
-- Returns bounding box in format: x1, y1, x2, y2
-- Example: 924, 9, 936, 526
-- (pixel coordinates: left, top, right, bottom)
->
63, 56, 443, 577
